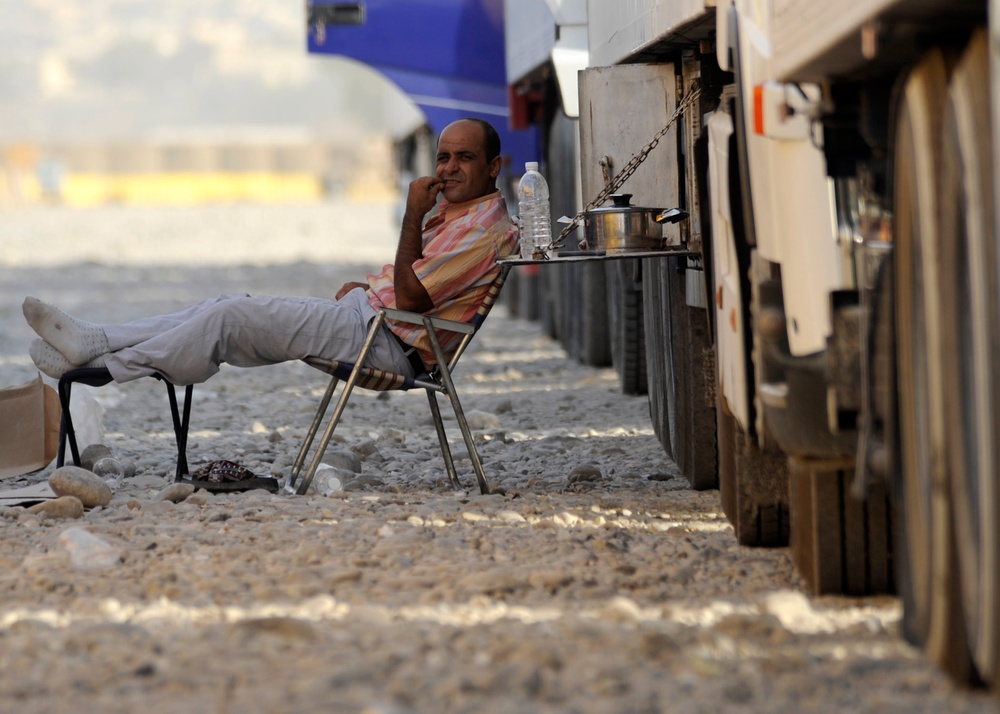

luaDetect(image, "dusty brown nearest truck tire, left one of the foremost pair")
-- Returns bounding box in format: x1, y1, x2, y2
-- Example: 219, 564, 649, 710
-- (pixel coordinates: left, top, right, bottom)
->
892, 50, 972, 681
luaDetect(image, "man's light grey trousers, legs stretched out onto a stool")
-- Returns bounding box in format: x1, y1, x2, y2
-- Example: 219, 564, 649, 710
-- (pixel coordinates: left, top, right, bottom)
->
102, 288, 413, 385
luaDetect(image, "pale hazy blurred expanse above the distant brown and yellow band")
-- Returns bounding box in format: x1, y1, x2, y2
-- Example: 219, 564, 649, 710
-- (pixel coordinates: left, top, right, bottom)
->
0, 0, 420, 141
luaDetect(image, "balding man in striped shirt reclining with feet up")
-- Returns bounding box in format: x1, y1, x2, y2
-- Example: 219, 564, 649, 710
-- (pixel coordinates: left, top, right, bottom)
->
23, 119, 517, 385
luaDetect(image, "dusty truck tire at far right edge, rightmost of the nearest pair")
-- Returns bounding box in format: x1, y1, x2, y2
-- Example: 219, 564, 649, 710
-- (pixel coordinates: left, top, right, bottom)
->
940, 30, 1000, 689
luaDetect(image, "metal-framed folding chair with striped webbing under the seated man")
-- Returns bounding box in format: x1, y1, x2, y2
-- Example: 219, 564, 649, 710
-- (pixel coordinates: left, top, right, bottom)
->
285, 265, 510, 495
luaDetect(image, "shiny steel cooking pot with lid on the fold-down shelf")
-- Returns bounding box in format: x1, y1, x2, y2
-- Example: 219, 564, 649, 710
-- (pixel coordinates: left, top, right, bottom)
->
580, 193, 687, 253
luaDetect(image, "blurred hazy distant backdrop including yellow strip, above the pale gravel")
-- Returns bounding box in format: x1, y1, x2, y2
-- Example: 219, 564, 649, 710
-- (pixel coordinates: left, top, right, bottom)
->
0, 0, 423, 208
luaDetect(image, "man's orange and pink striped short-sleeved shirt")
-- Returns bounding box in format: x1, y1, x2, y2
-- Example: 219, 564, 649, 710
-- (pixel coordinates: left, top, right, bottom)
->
367, 191, 518, 365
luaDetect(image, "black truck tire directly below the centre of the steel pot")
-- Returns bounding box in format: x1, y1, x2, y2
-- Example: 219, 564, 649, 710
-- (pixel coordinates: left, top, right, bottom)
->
607, 260, 647, 395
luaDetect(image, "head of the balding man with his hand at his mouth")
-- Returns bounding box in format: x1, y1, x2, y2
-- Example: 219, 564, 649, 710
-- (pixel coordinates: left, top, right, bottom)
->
434, 121, 500, 203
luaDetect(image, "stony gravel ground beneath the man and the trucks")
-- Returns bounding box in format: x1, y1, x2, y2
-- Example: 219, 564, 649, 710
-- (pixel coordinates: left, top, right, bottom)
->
0, 204, 1000, 714
